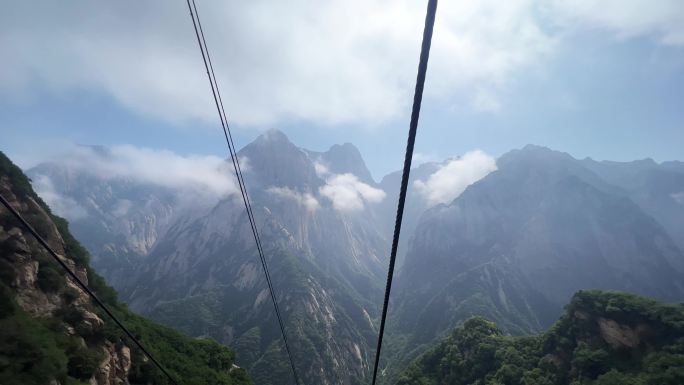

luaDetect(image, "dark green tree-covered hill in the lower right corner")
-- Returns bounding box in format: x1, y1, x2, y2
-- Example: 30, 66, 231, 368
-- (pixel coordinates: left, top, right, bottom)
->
399, 291, 684, 385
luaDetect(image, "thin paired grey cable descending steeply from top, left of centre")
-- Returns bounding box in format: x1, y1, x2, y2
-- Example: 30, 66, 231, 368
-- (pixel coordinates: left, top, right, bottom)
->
186, 0, 300, 384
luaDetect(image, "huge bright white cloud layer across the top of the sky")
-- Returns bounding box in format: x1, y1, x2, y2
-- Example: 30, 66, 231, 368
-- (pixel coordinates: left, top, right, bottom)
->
0, 0, 684, 126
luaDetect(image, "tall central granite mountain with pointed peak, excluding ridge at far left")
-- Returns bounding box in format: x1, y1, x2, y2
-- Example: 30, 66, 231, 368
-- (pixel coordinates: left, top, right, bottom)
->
123, 131, 386, 384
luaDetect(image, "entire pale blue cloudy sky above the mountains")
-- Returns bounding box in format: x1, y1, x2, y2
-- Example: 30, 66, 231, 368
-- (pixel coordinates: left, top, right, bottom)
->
0, 0, 684, 178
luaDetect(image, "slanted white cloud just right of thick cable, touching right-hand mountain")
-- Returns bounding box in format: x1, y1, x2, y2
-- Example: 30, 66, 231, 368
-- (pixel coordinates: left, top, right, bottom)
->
413, 150, 496, 205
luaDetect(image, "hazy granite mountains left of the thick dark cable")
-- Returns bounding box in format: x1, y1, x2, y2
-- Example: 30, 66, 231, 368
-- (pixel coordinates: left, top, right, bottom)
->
31, 130, 388, 384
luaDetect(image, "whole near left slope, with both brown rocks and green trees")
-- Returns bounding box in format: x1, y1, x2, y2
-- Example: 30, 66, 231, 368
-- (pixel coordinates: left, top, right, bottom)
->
0, 152, 251, 385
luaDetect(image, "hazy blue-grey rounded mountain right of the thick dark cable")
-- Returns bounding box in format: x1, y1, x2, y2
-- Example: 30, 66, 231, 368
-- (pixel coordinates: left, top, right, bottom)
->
380, 146, 684, 382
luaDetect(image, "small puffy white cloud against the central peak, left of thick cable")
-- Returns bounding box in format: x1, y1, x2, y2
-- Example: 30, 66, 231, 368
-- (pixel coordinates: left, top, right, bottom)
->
319, 173, 386, 211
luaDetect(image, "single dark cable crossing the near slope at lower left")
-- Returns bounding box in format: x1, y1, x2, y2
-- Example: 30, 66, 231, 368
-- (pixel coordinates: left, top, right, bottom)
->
0, 194, 178, 385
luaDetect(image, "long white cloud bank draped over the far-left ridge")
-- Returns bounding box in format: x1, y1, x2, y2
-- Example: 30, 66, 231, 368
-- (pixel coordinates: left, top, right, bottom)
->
40, 145, 237, 200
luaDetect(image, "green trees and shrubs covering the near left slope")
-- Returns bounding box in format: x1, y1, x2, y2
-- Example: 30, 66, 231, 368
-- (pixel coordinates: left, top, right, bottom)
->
0, 152, 251, 385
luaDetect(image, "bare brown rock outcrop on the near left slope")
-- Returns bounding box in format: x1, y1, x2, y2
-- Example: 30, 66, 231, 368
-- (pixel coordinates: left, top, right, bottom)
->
0, 154, 131, 385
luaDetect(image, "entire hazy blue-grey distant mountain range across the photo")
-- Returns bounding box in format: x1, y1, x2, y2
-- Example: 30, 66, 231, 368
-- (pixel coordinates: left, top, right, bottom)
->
28, 131, 684, 384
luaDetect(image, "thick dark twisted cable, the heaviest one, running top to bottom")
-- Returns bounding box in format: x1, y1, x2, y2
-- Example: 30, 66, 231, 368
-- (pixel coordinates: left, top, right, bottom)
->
373, 0, 437, 385
